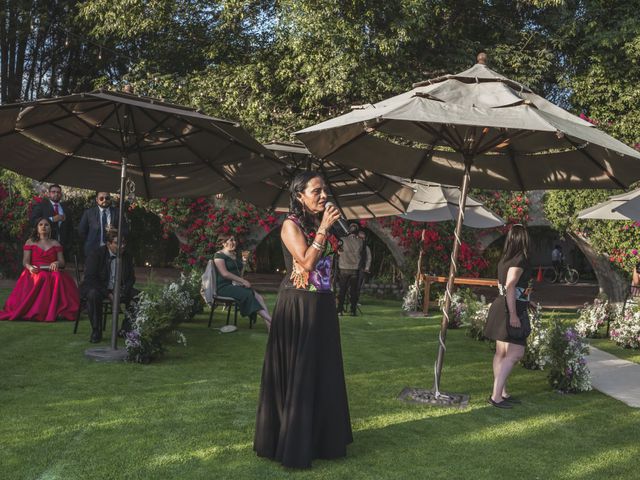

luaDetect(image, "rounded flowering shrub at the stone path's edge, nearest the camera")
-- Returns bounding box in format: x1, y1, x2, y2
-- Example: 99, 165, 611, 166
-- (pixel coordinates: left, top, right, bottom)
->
547, 320, 591, 393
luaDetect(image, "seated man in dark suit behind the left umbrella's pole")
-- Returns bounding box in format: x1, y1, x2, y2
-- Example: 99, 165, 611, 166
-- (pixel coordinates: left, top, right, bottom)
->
80, 230, 140, 343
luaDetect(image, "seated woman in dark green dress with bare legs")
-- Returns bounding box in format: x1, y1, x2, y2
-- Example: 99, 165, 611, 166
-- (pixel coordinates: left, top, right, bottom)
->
213, 235, 271, 330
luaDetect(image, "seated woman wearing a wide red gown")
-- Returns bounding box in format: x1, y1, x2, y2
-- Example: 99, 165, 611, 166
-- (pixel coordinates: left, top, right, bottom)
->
0, 218, 80, 322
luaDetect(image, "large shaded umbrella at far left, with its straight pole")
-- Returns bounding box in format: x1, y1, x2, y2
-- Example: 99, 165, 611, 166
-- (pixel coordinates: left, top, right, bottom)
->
0, 90, 279, 356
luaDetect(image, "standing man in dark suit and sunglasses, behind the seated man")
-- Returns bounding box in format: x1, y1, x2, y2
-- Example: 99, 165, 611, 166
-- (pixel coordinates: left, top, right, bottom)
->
78, 192, 129, 258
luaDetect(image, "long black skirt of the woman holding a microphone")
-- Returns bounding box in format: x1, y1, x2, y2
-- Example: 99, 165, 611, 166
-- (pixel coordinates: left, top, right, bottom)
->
253, 288, 353, 468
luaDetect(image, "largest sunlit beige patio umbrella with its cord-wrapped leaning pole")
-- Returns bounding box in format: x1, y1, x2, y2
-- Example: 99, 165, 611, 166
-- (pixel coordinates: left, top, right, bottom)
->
296, 54, 640, 403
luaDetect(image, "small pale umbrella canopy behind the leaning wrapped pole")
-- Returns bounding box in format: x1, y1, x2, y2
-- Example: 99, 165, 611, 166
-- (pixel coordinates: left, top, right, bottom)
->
399, 180, 505, 228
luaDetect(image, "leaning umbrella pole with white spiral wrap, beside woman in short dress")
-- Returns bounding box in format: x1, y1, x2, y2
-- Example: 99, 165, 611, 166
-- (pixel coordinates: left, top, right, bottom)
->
433, 157, 471, 398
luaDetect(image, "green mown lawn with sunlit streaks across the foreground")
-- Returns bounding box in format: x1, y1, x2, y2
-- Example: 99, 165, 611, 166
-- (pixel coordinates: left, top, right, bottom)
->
0, 290, 640, 480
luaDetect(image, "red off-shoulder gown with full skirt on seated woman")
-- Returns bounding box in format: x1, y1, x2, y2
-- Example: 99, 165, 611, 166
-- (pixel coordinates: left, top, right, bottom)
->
0, 245, 80, 322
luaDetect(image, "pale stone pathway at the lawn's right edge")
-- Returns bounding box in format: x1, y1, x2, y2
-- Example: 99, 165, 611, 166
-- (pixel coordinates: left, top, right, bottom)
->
587, 347, 640, 408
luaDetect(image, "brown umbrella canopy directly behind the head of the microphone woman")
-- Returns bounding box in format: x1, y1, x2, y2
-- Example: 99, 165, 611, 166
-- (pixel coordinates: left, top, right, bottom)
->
231, 142, 414, 219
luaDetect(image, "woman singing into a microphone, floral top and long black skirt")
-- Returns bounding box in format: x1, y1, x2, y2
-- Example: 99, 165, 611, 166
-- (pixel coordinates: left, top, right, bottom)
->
254, 172, 353, 468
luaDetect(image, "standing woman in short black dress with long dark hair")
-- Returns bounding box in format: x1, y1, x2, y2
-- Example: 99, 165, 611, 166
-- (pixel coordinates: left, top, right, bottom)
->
484, 224, 532, 408
